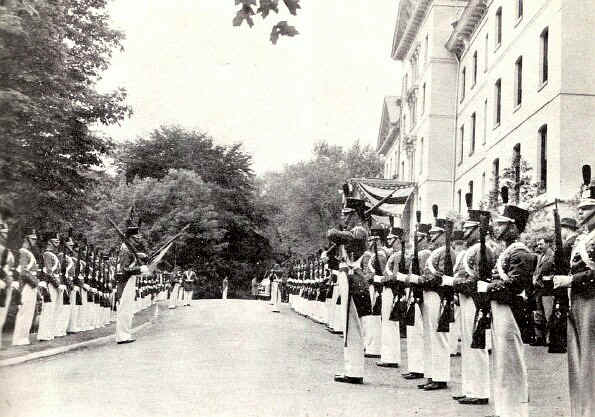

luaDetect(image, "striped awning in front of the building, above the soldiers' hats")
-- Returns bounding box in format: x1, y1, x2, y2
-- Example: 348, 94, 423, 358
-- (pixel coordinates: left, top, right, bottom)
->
347, 178, 416, 223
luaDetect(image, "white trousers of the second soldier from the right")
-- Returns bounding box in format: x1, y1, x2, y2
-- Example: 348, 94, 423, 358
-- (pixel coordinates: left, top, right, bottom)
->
490, 301, 528, 417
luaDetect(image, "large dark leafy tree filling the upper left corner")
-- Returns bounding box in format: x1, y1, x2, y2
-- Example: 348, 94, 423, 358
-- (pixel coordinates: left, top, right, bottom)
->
0, 0, 130, 226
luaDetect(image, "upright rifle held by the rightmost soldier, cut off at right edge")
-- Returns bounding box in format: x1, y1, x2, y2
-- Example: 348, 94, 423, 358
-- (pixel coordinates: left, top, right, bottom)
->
548, 199, 570, 353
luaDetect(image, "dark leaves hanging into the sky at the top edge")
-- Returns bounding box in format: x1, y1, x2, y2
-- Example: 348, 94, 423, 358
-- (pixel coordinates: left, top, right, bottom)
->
233, 0, 301, 44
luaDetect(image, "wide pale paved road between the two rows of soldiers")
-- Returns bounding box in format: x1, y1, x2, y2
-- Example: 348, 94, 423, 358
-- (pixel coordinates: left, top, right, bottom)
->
0, 300, 568, 417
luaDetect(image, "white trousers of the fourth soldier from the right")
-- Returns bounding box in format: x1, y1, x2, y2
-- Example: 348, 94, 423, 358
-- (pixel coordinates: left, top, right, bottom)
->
421, 290, 450, 380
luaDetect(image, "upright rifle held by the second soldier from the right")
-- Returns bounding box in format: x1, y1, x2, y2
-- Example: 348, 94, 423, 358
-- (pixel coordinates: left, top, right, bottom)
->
471, 216, 492, 349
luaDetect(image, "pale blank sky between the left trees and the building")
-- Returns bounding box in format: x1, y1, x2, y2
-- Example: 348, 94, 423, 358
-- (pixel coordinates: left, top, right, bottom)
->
100, 0, 400, 174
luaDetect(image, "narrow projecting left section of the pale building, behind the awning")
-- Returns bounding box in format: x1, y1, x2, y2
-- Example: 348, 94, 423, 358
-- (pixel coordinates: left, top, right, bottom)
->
378, 0, 466, 229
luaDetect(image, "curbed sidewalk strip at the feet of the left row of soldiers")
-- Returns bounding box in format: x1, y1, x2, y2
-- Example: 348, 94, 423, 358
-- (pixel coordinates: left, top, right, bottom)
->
0, 302, 167, 367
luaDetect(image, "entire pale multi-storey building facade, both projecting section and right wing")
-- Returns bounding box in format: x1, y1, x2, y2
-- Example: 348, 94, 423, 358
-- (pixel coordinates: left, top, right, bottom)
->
378, 0, 595, 221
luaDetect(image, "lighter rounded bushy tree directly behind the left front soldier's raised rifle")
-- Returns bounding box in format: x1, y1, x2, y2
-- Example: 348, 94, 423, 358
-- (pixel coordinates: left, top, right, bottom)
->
86, 169, 225, 269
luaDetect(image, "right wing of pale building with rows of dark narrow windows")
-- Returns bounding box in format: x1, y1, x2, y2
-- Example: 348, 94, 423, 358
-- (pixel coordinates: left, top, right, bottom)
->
446, 0, 595, 212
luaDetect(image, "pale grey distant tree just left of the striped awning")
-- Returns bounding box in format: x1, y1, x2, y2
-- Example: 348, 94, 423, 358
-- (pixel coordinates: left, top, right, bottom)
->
259, 141, 382, 256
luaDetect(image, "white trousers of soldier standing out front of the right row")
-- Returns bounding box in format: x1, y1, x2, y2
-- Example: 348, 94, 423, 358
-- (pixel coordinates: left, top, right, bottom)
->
338, 271, 364, 378
